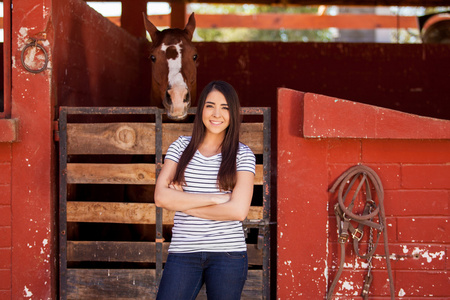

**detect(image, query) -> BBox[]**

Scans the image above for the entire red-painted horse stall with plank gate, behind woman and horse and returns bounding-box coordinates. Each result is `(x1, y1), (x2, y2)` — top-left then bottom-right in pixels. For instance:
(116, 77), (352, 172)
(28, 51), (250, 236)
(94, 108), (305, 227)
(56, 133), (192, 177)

(0, 0), (450, 299)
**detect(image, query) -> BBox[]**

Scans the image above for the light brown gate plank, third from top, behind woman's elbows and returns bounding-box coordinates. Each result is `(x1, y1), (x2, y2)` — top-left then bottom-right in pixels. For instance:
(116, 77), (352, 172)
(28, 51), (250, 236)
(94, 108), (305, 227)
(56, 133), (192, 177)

(67, 201), (263, 225)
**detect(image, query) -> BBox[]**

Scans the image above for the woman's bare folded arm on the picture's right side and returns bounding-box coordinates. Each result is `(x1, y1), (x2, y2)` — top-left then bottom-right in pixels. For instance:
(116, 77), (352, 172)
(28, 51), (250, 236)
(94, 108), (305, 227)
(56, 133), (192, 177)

(183, 171), (255, 221)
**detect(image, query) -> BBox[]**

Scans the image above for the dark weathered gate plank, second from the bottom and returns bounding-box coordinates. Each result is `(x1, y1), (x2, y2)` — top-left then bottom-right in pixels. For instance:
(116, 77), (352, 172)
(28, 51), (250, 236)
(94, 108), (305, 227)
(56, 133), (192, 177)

(67, 241), (262, 266)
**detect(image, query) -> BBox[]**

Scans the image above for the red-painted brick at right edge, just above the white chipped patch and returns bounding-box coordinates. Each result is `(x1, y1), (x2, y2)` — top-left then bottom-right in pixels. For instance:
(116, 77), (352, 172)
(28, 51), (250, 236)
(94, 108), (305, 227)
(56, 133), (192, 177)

(397, 217), (450, 243)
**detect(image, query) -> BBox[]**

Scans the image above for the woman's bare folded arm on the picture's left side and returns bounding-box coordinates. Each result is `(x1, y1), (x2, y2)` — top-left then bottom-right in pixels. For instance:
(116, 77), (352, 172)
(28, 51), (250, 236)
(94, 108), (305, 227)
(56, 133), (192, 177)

(155, 159), (230, 211)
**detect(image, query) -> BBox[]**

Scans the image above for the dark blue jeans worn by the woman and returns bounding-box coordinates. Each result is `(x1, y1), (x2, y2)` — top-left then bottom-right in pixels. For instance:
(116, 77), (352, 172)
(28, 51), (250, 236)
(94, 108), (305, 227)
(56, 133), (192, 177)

(156, 251), (248, 300)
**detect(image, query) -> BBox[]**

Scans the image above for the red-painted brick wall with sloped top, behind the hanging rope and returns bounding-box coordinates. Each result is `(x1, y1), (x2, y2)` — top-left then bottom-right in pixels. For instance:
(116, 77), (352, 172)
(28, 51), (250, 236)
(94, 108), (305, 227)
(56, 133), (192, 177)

(277, 89), (450, 299)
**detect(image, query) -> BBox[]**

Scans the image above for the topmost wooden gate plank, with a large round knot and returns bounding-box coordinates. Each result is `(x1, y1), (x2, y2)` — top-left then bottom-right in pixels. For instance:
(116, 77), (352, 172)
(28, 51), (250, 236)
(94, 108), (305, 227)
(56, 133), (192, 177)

(67, 123), (263, 155)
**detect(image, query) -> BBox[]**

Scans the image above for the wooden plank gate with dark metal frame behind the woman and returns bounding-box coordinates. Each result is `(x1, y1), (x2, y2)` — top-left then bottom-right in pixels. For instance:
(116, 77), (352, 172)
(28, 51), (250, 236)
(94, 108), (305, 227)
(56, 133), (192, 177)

(59, 107), (270, 299)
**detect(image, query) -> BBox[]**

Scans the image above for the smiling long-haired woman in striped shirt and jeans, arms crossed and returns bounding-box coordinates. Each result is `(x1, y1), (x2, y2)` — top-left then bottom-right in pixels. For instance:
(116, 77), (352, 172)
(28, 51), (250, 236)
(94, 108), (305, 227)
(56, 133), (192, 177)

(155, 81), (255, 300)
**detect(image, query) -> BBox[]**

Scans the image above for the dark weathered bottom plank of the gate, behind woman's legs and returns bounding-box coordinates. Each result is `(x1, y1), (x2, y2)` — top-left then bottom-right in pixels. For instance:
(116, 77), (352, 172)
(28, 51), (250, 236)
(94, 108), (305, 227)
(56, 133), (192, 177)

(67, 269), (263, 299)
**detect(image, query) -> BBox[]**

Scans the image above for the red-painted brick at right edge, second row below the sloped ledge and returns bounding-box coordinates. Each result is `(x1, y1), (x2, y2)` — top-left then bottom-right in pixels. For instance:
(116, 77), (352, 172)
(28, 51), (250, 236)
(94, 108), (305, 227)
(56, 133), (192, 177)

(402, 164), (450, 189)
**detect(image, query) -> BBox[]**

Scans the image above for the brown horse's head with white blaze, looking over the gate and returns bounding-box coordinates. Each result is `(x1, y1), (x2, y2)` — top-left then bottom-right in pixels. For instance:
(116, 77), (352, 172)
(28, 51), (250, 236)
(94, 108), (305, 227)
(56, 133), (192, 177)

(144, 13), (197, 120)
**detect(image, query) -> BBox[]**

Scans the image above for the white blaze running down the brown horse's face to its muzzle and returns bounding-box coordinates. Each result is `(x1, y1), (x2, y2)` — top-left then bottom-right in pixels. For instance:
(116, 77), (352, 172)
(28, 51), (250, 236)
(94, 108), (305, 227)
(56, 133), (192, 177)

(161, 42), (190, 120)
